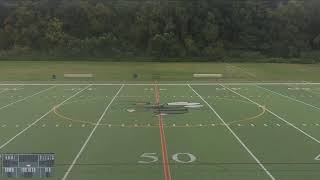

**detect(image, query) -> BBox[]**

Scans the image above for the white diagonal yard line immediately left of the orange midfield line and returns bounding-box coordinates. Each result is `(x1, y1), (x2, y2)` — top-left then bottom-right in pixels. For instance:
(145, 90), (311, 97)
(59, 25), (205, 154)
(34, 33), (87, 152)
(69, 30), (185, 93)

(62, 84), (124, 180)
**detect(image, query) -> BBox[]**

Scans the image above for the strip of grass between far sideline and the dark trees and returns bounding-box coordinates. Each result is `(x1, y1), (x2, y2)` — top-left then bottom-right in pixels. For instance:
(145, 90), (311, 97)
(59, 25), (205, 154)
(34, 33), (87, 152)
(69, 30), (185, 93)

(0, 61), (320, 81)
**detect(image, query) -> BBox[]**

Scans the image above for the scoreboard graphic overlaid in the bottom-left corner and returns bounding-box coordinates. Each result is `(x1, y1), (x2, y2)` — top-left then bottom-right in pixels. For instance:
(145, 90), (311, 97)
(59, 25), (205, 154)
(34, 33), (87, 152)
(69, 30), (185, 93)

(1, 153), (55, 178)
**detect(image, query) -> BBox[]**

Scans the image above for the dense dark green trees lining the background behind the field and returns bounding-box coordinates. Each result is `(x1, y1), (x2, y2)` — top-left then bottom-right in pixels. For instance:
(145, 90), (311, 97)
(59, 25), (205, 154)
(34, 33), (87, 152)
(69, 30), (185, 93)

(0, 0), (320, 61)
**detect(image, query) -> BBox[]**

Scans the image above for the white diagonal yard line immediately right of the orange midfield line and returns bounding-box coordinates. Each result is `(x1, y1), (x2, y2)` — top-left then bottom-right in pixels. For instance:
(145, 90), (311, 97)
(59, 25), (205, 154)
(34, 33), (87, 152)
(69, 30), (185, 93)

(188, 85), (275, 180)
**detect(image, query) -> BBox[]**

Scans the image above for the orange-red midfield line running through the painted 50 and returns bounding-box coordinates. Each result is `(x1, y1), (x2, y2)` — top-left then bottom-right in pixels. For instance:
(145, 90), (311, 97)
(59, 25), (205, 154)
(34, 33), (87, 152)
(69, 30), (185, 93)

(154, 83), (171, 180)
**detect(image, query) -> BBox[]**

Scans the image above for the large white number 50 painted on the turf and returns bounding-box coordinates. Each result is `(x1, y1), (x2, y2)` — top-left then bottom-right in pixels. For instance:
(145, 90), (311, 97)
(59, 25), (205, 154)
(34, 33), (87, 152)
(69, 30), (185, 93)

(138, 153), (197, 164)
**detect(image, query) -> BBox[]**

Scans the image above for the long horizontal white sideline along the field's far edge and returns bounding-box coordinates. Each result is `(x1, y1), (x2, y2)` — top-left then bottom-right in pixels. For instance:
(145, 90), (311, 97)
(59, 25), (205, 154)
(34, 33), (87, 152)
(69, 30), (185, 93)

(0, 82), (320, 86)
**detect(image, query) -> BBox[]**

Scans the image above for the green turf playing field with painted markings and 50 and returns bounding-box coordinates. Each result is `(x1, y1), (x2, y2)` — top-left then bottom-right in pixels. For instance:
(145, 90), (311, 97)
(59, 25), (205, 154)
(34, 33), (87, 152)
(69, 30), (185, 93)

(0, 83), (320, 180)
